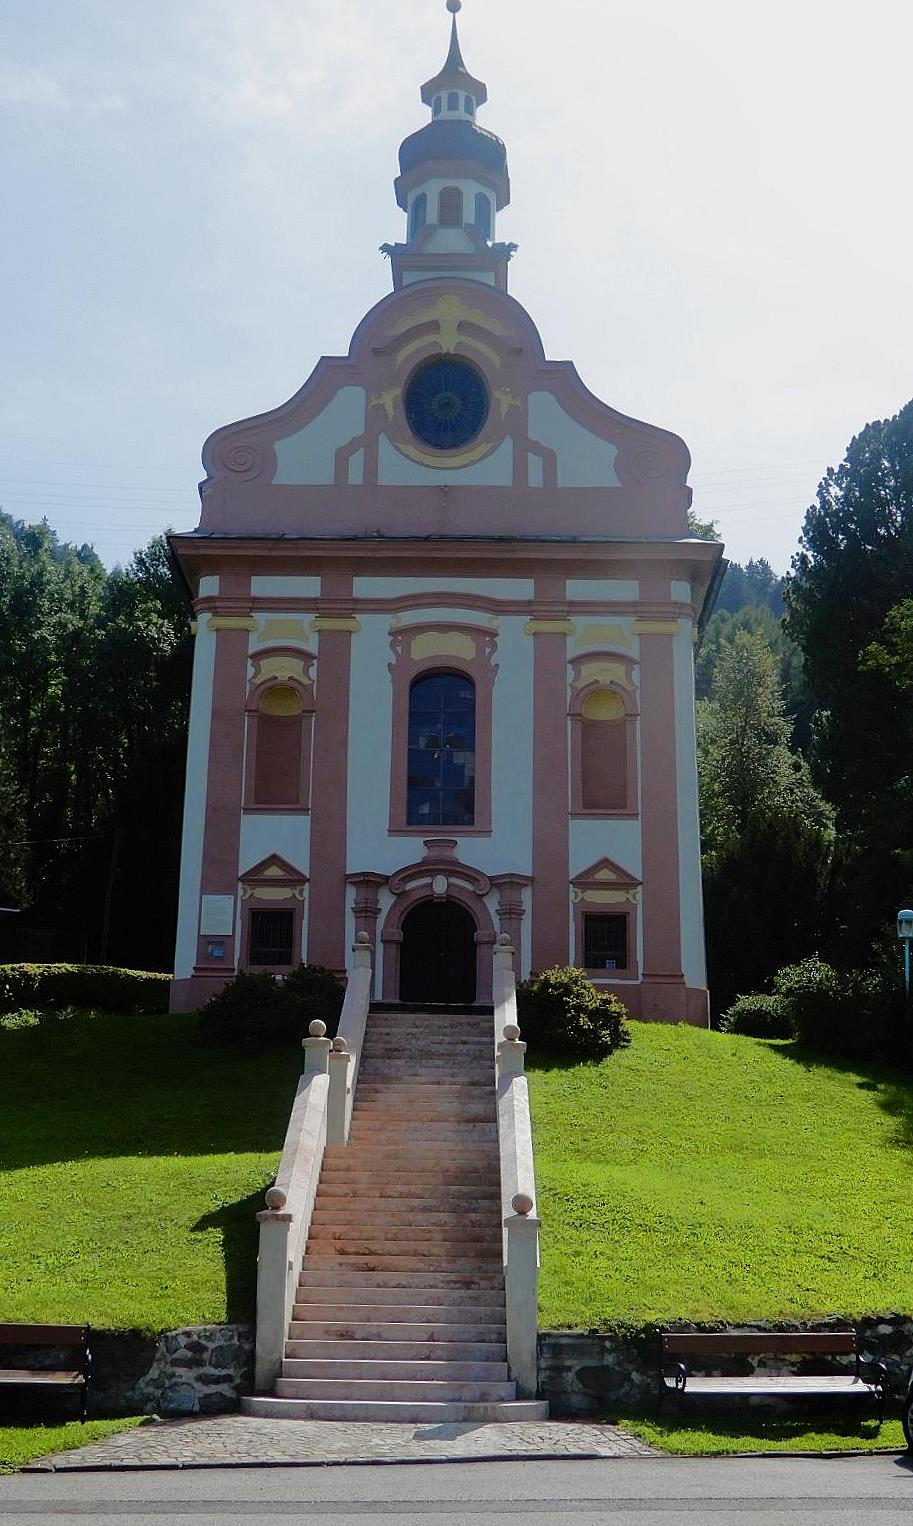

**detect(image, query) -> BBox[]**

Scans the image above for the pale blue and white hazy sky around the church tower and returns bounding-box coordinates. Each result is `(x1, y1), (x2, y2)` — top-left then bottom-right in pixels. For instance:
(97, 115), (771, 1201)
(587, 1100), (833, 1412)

(0, 0), (913, 571)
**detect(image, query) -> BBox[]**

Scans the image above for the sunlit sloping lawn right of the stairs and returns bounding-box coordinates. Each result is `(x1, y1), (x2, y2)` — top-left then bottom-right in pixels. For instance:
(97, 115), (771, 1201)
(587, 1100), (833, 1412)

(528, 1022), (913, 1329)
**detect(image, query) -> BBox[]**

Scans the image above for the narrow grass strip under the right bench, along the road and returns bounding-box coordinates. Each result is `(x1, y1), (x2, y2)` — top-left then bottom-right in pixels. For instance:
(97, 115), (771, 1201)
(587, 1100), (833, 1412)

(609, 1410), (907, 1457)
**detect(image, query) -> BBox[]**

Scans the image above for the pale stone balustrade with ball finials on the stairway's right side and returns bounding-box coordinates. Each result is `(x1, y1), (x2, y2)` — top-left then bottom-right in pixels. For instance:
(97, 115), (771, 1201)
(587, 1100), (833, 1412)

(492, 940), (540, 1398)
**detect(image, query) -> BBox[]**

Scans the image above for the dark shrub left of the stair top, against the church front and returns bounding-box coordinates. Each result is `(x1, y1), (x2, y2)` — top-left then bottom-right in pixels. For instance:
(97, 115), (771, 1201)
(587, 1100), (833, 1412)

(200, 964), (345, 1053)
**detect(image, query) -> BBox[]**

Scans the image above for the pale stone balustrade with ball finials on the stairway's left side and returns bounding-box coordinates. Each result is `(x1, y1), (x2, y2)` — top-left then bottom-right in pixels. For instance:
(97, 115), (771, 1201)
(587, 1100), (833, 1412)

(255, 934), (371, 1392)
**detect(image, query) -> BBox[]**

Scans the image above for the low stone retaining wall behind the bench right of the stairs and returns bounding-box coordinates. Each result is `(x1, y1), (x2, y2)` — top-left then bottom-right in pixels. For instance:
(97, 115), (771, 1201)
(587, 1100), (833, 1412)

(539, 1314), (913, 1416)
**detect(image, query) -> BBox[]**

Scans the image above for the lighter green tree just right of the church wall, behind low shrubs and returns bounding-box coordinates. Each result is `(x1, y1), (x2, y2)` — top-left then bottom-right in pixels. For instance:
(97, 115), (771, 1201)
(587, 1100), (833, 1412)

(698, 629), (834, 1012)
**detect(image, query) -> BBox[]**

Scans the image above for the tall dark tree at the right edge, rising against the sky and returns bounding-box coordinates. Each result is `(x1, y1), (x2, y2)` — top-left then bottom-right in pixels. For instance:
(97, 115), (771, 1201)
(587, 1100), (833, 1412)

(786, 401), (913, 961)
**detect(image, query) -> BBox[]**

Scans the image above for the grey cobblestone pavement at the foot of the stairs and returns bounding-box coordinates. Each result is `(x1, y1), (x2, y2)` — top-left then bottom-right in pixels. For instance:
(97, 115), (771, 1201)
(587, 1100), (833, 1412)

(26, 1415), (653, 1471)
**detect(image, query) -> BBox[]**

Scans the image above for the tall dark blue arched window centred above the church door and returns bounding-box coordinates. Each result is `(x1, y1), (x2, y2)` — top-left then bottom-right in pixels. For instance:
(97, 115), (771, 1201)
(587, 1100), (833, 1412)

(406, 673), (475, 827)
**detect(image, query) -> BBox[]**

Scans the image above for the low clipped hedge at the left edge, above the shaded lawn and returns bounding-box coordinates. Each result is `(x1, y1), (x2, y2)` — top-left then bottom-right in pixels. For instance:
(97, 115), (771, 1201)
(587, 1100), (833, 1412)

(0, 964), (171, 1013)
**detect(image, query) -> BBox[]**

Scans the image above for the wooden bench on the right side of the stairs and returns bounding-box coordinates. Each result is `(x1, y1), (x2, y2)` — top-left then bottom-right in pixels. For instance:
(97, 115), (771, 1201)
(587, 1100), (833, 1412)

(660, 1331), (887, 1421)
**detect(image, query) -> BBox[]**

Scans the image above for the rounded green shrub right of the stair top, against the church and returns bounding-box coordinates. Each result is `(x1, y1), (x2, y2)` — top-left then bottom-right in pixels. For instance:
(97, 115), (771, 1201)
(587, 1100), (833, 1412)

(518, 964), (631, 1059)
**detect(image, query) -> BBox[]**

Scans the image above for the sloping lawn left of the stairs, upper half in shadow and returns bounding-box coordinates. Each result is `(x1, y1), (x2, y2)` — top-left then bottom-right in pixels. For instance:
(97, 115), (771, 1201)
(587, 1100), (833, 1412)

(0, 1013), (301, 1334)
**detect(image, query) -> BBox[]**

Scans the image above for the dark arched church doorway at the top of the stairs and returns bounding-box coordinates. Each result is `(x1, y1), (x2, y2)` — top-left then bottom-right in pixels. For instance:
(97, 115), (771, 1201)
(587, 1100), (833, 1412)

(400, 900), (476, 1006)
